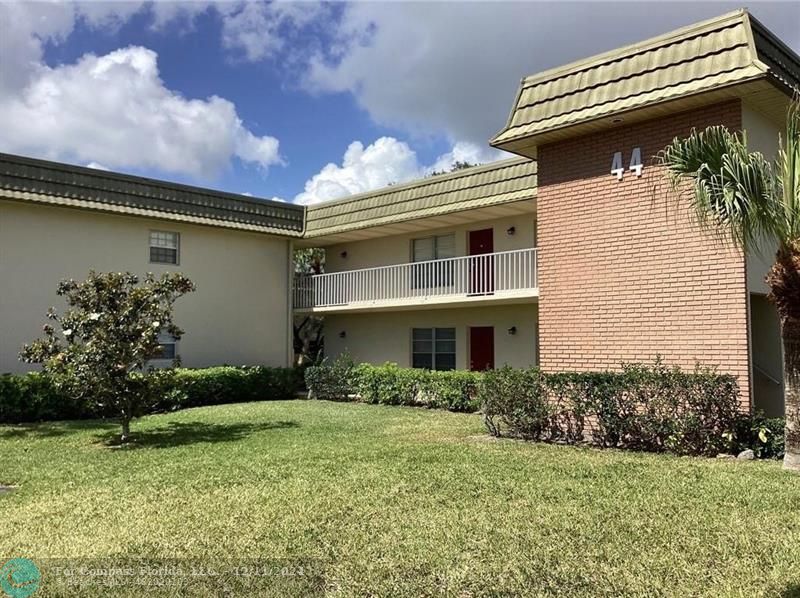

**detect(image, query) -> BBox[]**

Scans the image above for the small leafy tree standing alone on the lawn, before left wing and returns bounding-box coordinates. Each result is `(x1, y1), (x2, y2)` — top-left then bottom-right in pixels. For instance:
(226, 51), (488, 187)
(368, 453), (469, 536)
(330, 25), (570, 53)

(20, 271), (195, 443)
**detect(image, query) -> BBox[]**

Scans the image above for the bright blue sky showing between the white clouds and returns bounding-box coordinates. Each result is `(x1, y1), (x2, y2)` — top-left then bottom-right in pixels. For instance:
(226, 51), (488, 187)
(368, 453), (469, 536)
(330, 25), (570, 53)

(40, 4), (418, 197)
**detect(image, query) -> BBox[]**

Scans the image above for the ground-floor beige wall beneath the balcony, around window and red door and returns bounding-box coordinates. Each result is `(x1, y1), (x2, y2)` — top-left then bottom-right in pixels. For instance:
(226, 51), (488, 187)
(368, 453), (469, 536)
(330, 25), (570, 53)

(325, 303), (538, 369)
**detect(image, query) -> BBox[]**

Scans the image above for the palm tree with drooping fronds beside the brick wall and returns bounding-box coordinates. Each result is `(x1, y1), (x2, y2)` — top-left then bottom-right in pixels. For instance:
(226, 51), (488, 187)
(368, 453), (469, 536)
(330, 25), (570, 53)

(657, 95), (800, 471)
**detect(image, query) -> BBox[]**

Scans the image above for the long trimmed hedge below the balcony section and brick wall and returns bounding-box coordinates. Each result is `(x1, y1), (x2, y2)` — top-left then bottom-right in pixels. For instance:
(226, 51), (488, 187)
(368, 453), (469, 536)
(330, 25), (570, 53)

(305, 355), (783, 457)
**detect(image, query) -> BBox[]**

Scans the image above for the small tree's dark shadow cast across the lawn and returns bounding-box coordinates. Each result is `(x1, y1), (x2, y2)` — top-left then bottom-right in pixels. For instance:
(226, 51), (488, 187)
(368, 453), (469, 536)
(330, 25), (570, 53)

(97, 421), (300, 449)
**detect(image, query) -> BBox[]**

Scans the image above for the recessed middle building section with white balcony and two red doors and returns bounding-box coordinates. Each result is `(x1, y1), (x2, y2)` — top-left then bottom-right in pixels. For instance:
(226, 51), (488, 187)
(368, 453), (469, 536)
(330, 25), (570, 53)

(294, 158), (539, 370)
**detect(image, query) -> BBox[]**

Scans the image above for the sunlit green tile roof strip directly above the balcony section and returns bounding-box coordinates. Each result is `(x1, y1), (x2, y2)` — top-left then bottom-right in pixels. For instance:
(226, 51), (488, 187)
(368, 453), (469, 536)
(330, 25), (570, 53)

(305, 158), (536, 237)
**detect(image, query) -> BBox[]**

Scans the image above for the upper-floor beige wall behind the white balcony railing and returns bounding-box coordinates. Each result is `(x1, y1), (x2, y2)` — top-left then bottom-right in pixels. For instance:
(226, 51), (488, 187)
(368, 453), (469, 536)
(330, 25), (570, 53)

(325, 214), (535, 272)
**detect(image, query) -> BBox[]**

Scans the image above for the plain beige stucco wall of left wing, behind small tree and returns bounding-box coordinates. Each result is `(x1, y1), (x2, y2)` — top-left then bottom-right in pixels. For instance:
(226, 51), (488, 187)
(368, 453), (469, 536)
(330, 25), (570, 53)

(0, 201), (290, 372)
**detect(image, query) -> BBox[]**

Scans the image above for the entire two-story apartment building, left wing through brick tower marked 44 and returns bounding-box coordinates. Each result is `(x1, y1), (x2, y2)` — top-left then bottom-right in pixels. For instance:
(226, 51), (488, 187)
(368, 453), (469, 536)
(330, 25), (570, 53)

(0, 11), (800, 420)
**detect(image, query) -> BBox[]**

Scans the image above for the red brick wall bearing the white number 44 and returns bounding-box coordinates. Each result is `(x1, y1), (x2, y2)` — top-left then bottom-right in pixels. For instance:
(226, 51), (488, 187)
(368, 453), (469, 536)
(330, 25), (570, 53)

(538, 101), (749, 410)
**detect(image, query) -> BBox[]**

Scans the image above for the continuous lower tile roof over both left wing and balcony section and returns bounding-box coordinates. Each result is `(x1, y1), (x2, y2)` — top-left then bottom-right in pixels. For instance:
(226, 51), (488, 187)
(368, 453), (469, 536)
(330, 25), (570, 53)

(0, 153), (536, 237)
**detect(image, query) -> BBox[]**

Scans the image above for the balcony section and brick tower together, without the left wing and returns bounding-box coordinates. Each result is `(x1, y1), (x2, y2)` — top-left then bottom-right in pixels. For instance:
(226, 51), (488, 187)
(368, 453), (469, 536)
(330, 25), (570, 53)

(295, 11), (800, 413)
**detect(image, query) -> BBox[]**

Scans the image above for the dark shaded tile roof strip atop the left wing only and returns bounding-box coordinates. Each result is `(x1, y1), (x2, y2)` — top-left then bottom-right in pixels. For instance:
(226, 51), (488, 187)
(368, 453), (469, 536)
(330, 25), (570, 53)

(0, 154), (304, 237)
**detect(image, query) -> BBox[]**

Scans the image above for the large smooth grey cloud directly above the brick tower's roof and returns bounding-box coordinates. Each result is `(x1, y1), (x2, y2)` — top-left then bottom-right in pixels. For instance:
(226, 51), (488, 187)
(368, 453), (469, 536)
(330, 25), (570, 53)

(304, 2), (800, 146)
